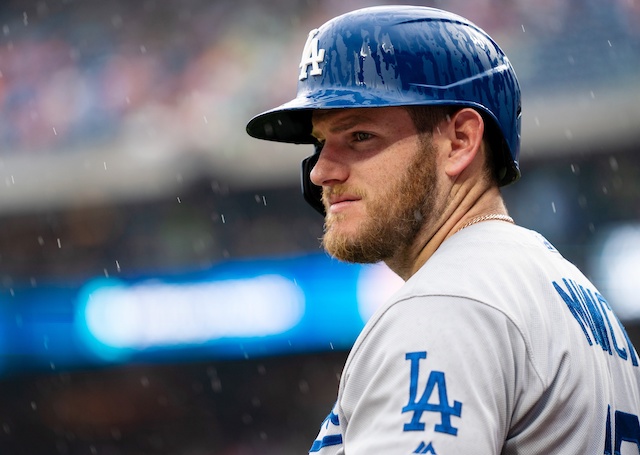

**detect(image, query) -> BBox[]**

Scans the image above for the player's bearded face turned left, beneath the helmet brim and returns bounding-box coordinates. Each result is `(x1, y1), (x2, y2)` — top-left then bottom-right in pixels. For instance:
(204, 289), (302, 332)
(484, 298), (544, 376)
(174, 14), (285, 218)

(311, 107), (437, 263)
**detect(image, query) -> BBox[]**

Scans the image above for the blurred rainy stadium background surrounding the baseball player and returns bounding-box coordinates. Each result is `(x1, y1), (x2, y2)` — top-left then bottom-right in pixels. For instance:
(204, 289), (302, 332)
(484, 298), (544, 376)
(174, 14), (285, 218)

(0, 0), (640, 455)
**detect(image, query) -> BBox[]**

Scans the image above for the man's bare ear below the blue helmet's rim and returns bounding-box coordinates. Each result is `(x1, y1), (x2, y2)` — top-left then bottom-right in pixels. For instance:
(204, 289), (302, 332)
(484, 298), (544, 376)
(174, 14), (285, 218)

(440, 108), (484, 178)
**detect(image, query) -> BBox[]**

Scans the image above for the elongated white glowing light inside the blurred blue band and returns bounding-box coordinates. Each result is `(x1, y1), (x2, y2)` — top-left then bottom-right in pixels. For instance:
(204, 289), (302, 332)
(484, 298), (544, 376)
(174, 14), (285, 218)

(80, 275), (304, 351)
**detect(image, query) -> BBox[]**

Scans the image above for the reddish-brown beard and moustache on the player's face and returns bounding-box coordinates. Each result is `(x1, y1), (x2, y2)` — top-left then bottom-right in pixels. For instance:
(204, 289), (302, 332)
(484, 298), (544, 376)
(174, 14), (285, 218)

(322, 139), (437, 264)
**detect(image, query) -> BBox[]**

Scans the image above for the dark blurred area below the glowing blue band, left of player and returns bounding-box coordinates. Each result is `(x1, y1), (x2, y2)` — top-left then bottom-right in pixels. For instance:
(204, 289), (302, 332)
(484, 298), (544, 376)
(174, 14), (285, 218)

(0, 352), (346, 455)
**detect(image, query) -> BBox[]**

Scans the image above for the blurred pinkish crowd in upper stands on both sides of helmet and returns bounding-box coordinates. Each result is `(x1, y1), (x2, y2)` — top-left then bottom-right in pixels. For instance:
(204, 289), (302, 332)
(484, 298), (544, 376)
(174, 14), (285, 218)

(0, 0), (640, 156)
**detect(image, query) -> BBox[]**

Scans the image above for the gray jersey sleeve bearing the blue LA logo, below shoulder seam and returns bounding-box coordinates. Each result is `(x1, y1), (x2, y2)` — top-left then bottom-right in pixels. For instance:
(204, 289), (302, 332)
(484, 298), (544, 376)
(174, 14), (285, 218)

(336, 296), (542, 455)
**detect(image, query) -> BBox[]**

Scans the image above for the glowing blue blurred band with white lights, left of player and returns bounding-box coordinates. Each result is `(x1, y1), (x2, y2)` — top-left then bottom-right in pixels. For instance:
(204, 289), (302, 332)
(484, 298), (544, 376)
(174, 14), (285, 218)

(0, 254), (402, 371)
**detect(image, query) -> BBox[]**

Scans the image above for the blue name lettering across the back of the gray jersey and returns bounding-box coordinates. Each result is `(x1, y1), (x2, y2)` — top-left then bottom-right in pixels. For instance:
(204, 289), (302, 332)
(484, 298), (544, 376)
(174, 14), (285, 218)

(553, 278), (638, 367)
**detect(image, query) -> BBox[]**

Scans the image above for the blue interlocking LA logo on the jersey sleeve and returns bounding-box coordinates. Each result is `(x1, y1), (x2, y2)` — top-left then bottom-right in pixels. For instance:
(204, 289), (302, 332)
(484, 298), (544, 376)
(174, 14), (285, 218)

(402, 351), (462, 436)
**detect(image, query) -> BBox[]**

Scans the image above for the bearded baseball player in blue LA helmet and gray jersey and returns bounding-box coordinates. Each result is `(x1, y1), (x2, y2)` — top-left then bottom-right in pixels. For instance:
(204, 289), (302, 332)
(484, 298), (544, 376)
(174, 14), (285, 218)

(247, 6), (640, 455)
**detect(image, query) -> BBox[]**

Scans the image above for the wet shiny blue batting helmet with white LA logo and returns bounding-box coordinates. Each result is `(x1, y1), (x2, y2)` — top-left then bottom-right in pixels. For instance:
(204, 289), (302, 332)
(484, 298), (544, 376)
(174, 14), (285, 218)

(247, 6), (521, 216)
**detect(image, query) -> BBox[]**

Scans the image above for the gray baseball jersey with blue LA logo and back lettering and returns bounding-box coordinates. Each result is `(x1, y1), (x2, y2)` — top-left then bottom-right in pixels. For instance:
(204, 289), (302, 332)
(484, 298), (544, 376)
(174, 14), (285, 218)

(309, 221), (640, 455)
